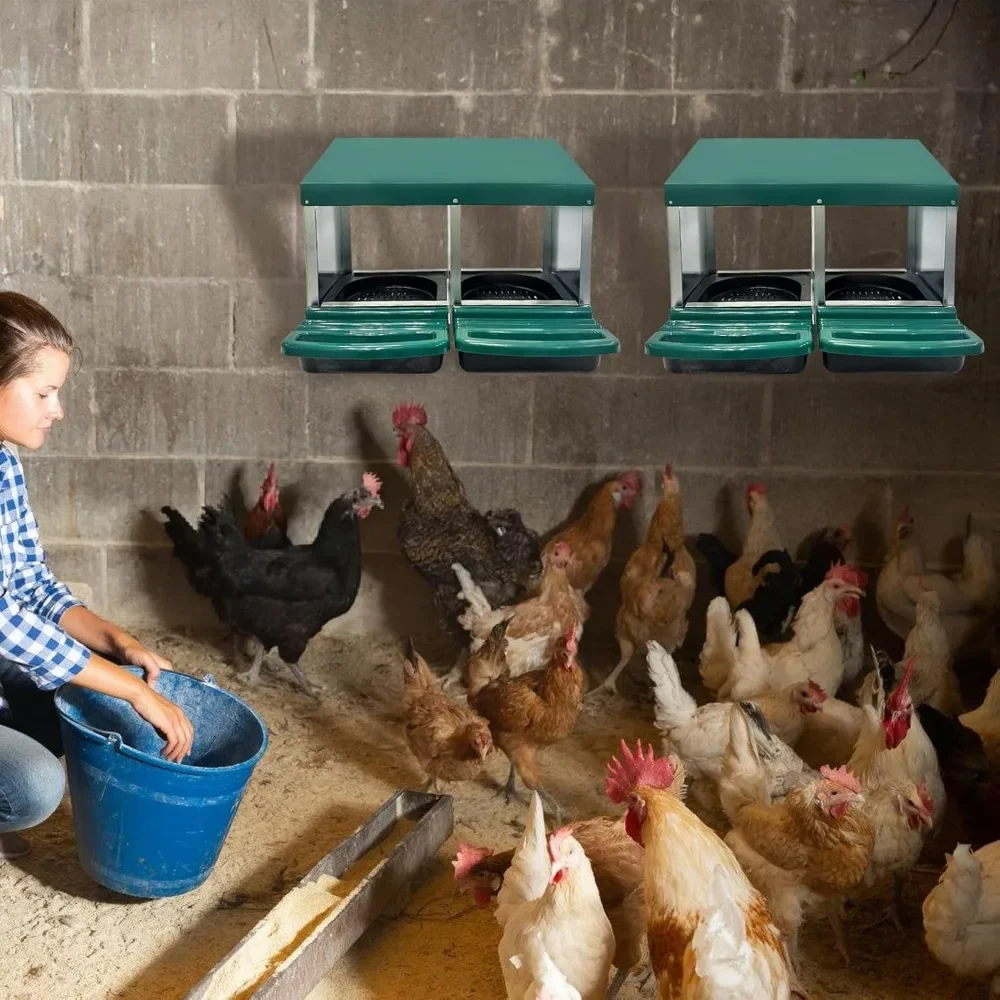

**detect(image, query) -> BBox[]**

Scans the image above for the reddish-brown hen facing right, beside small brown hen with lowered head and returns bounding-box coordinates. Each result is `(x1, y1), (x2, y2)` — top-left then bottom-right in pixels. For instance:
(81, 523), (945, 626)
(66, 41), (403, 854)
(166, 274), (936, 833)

(469, 629), (583, 816)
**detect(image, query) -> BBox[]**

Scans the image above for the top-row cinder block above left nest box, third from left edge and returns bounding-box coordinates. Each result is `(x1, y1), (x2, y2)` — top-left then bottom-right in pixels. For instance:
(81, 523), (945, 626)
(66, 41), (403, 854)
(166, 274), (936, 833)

(316, 0), (537, 91)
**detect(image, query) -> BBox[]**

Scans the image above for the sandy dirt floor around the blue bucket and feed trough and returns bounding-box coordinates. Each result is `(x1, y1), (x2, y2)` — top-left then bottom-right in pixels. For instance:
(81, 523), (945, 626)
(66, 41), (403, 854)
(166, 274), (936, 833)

(0, 633), (986, 1000)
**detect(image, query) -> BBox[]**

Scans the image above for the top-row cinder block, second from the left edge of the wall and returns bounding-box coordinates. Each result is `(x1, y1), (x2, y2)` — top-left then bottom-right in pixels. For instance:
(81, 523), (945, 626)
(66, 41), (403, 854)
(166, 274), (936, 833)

(90, 0), (308, 90)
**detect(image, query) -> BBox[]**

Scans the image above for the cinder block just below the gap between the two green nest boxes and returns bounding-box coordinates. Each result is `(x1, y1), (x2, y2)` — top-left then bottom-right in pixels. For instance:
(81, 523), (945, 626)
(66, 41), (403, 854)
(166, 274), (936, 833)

(533, 376), (764, 466)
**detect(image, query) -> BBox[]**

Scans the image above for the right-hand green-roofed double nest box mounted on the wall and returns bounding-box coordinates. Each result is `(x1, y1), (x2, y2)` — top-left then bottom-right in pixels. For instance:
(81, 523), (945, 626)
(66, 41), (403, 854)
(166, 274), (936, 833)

(646, 139), (983, 374)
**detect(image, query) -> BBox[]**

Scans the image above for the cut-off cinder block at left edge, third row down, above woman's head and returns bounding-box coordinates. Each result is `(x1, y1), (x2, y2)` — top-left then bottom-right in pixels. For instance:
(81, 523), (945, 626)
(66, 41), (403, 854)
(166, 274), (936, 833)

(0, 186), (87, 277)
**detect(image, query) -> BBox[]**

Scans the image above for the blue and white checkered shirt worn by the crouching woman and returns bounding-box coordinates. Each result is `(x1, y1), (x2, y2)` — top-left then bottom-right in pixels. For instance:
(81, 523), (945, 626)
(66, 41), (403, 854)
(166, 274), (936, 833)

(0, 445), (90, 715)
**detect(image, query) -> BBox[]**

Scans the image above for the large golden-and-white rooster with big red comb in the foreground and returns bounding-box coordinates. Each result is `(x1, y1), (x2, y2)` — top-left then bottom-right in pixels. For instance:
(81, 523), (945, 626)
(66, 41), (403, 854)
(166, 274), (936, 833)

(605, 740), (791, 1000)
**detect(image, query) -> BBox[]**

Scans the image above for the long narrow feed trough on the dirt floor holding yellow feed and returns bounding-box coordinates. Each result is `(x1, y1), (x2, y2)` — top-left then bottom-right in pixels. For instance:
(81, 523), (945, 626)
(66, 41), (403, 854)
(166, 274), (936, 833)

(185, 791), (454, 1000)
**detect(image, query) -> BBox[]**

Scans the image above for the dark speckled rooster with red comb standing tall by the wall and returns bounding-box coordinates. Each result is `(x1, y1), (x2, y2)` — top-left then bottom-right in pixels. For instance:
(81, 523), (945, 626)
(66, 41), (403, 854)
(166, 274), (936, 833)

(392, 404), (541, 645)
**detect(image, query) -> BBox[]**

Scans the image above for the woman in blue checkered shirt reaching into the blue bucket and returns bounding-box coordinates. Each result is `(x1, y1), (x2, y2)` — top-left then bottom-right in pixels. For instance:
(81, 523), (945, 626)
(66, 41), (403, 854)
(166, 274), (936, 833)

(0, 292), (194, 859)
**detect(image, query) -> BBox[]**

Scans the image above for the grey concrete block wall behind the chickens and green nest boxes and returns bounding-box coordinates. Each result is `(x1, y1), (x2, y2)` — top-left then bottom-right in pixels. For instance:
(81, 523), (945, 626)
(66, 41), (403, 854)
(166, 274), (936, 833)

(0, 0), (1000, 648)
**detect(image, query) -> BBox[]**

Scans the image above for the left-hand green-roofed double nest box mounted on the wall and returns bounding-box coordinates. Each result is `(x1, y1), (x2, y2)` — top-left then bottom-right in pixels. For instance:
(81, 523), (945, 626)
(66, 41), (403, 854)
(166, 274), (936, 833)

(282, 138), (619, 373)
